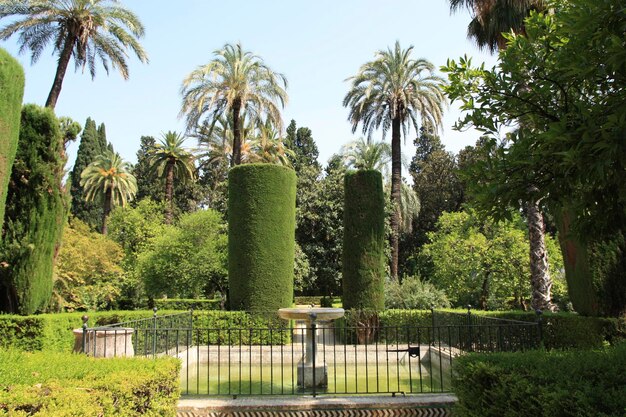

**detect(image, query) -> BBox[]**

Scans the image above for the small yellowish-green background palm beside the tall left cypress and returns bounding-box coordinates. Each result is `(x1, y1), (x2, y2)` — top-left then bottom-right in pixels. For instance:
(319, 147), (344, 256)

(80, 150), (137, 235)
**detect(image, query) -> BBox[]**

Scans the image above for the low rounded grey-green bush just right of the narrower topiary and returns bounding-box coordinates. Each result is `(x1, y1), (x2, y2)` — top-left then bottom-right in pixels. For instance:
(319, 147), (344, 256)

(385, 276), (450, 310)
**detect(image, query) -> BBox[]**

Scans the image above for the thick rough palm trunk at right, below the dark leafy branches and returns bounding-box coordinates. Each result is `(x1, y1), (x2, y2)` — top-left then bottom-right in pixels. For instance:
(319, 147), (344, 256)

(526, 200), (555, 311)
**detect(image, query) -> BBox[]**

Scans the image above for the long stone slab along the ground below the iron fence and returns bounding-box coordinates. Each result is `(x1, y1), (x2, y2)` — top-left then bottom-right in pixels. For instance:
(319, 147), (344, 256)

(177, 394), (456, 417)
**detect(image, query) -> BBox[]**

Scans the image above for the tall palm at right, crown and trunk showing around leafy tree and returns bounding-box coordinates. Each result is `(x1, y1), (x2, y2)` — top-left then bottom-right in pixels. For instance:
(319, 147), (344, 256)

(449, 0), (555, 310)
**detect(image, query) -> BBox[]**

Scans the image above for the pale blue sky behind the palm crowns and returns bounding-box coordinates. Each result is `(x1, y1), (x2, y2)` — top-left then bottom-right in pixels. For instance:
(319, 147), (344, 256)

(0, 0), (495, 169)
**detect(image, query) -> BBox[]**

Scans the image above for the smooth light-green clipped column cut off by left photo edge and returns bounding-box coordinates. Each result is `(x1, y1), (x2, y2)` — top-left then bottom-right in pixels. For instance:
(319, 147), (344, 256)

(0, 49), (24, 230)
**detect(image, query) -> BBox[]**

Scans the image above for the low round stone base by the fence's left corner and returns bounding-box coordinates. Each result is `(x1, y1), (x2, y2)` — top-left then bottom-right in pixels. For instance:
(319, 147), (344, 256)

(74, 327), (135, 358)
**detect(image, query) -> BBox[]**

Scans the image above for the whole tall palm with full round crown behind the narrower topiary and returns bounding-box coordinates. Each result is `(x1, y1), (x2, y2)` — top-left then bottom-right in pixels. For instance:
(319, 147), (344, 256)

(343, 42), (446, 280)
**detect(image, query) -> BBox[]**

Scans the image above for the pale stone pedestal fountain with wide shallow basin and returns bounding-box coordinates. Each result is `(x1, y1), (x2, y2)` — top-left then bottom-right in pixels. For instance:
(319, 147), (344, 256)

(278, 307), (345, 388)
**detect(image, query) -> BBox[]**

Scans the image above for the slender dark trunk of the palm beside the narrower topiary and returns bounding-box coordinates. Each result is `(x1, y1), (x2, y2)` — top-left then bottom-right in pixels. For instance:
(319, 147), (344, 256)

(391, 117), (402, 281)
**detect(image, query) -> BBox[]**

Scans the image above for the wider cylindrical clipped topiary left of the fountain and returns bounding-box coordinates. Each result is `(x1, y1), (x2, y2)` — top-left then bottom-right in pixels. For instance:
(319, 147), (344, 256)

(228, 164), (296, 311)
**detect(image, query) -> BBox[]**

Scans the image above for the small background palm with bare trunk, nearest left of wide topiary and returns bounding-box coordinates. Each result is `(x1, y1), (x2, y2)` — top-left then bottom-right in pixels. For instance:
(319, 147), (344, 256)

(149, 131), (196, 224)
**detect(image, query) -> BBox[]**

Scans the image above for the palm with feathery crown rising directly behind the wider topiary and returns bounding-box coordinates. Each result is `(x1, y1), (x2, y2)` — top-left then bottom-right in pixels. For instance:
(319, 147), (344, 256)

(180, 43), (287, 166)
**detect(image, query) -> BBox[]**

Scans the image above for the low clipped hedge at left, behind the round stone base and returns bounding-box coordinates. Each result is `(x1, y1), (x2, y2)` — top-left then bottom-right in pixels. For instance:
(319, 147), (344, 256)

(0, 310), (178, 352)
